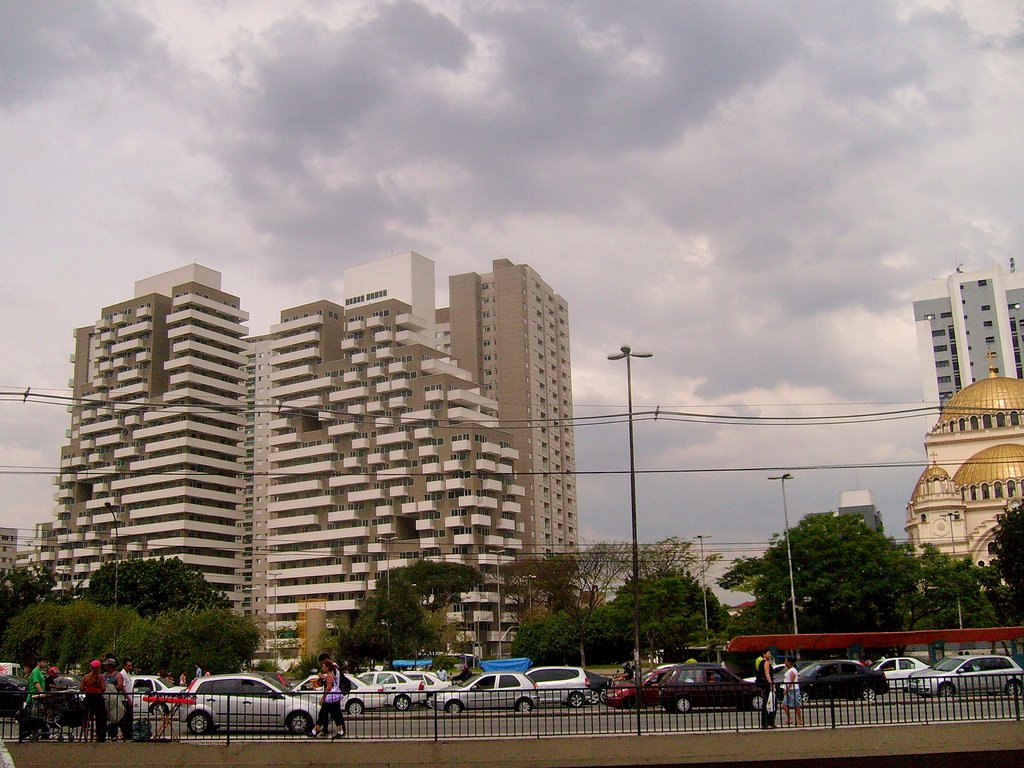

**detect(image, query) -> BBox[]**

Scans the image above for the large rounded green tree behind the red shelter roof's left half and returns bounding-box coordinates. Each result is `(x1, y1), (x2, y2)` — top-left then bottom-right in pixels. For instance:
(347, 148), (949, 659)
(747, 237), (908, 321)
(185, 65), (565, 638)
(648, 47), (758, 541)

(719, 515), (915, 632)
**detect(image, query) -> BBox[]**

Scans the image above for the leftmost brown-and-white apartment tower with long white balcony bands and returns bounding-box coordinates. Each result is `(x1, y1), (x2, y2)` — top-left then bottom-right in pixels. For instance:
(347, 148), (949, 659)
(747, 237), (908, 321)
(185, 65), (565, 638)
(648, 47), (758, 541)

(52, 264), (248, 603)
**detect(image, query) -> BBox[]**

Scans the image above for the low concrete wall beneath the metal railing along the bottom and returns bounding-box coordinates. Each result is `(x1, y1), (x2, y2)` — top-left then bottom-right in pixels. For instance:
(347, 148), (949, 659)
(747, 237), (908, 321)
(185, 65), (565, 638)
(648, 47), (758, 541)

(7, 722), (1024, 768)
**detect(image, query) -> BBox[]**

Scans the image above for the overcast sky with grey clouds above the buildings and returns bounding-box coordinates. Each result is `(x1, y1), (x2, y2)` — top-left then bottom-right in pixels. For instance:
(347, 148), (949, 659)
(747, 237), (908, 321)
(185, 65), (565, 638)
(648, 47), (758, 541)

(0, 0), (1024, 589)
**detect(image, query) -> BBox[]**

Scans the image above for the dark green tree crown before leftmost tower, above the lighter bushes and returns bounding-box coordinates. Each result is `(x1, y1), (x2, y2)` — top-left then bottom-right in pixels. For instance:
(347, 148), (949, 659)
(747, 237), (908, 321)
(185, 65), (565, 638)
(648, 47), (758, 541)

(84, 557), (228, 617)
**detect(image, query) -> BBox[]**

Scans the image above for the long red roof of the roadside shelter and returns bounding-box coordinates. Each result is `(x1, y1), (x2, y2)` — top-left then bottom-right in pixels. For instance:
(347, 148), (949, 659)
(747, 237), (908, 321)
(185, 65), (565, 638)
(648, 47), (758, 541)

(725, 627), (1024, 652)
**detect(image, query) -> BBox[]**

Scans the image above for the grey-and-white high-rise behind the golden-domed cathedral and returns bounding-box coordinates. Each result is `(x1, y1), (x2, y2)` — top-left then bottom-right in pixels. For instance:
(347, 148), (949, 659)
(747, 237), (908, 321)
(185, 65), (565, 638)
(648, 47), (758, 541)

(912, 263), (1024, 403)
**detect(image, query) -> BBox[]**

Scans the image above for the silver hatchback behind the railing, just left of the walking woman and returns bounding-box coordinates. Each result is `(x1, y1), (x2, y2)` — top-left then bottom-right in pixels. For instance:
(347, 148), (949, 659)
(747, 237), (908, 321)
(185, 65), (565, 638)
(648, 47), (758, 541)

(178, 674), (316, 735)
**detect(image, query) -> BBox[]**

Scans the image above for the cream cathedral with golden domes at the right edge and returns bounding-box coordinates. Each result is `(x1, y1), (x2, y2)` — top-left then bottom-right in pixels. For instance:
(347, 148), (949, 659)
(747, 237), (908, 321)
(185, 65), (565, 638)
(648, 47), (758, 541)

(906, 368), (1024, 565)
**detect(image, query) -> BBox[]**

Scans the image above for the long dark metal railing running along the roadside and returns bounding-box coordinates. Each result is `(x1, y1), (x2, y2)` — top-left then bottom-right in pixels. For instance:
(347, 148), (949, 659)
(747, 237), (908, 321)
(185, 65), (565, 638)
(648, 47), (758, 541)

(0, 676), (1024, 742)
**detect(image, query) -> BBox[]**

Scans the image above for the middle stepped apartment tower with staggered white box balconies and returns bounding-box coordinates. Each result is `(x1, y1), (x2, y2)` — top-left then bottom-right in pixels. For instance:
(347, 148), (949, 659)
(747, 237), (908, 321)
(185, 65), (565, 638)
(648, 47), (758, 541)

(265, 259), (525, 652)
